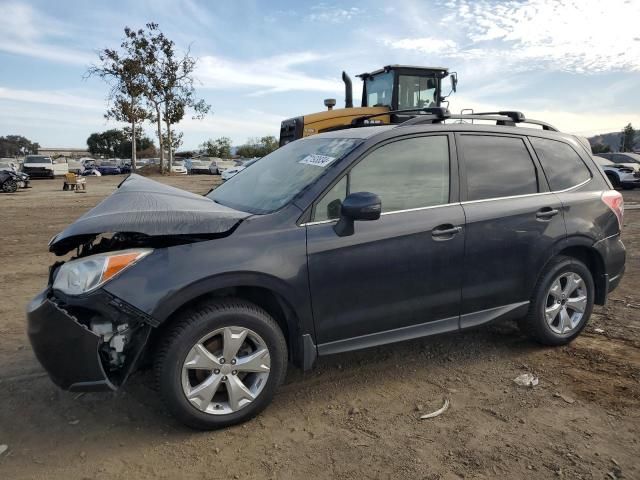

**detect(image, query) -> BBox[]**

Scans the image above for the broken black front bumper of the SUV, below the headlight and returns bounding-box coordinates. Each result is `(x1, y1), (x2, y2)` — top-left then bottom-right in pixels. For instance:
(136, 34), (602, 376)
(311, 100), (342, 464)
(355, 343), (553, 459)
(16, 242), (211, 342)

(27, 288), (153, 391)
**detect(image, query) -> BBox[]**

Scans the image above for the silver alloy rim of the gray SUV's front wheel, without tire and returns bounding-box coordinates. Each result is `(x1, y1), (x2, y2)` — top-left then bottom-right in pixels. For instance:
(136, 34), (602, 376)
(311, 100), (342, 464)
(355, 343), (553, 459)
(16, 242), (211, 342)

(182, 326), (271, 415)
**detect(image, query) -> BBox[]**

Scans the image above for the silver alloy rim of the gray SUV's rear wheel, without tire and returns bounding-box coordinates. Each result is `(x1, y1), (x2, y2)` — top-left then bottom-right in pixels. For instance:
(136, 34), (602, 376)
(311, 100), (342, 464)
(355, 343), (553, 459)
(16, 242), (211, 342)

(544, 272), (588, 335)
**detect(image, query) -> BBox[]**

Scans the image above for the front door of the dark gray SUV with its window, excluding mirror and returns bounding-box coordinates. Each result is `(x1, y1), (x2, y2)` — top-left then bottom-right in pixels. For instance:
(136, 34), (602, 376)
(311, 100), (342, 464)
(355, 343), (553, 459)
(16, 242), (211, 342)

(306, 134), (464, 354)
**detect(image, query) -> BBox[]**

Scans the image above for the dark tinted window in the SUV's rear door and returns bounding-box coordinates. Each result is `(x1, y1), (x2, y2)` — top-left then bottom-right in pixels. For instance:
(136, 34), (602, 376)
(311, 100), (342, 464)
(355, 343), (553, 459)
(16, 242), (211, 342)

(460, 135), (538, 200)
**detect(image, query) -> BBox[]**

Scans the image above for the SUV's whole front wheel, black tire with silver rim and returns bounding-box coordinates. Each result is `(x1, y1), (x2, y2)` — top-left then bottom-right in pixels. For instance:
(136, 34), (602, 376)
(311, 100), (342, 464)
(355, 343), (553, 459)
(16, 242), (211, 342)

(155, 299), (287, 430)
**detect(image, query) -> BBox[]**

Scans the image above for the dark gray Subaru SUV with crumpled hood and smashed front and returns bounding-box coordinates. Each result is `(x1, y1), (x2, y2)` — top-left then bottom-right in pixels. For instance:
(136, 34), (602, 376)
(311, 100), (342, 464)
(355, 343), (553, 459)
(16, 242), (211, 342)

(28, 111), (625, 429)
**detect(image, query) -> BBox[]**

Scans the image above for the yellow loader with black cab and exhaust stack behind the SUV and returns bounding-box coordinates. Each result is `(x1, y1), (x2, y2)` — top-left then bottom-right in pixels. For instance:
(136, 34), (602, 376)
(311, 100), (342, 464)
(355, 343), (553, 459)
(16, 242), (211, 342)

(280, 65), (458, 146)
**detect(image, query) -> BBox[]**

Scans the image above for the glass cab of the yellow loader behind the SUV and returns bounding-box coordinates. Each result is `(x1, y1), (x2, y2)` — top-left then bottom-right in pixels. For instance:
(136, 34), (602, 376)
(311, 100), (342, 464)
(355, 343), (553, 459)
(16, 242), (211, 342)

(358, 65), (456, 110)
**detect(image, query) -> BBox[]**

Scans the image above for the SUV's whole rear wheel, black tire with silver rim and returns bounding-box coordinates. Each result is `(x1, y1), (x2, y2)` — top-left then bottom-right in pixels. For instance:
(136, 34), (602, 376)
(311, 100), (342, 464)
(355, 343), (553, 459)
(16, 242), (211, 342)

(520, 256), (595, 346)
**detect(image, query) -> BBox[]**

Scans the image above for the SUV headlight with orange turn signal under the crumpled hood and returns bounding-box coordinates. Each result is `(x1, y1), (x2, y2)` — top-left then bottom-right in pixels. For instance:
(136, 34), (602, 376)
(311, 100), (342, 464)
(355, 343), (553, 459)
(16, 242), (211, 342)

(53, 248), (153, 295)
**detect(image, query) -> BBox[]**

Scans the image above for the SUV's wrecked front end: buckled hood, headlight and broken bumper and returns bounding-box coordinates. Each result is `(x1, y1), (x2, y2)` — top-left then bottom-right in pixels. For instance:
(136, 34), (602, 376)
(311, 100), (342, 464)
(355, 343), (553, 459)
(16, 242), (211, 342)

(27, 175), (249, 390)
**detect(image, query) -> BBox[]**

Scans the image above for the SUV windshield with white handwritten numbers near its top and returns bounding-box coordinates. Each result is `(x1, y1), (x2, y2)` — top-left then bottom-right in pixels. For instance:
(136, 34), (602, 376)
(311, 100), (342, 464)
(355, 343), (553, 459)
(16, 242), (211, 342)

(207, 137), (362, 214)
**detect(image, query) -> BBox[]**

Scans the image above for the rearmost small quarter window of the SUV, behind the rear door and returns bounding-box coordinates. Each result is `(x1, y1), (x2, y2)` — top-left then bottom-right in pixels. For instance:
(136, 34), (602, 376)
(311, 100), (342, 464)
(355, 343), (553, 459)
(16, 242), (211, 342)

(529, 138), (591, 190)
